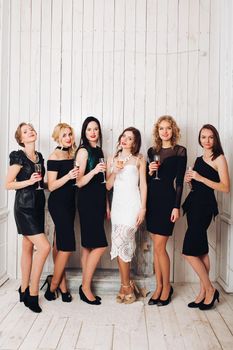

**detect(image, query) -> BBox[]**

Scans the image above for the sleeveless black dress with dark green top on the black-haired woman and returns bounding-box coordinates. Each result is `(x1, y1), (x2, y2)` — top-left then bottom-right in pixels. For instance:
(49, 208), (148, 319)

(78, 146), (108, 248)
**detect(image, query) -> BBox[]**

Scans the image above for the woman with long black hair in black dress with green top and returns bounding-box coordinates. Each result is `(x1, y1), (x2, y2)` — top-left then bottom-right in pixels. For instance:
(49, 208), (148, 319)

(76, 117), (108, 305)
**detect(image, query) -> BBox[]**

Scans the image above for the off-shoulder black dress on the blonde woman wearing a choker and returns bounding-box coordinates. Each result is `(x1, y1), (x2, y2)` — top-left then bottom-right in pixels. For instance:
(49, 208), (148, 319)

(47, 159), (76, 252)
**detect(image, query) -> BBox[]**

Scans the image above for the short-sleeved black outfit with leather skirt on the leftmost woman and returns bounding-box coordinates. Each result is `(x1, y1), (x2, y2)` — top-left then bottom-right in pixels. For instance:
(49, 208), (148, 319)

(10, 150), (45, 236)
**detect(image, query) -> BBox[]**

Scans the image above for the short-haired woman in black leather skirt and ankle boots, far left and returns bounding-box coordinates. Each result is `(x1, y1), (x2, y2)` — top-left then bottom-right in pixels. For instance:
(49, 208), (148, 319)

(6, 123), (50, 313)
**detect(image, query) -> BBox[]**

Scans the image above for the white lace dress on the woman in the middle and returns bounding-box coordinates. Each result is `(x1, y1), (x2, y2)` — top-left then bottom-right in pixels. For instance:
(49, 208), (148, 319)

(111, 163), (141, 262)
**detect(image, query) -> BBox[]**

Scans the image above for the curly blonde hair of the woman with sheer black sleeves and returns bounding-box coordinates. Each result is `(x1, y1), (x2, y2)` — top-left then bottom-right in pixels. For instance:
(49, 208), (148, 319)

(153, 115), (180, 152)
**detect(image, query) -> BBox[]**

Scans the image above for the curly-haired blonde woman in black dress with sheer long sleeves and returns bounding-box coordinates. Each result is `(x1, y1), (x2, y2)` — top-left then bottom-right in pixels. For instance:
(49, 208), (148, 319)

(146, 116), (187, 306)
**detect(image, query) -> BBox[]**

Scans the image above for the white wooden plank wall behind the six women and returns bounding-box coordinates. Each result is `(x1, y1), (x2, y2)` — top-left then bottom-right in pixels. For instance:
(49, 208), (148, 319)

(0, 0), (231, 281)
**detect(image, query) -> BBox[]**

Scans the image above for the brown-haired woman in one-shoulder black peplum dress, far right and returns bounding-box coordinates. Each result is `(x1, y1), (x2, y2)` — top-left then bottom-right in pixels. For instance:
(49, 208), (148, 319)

(182, 124), (230, 310)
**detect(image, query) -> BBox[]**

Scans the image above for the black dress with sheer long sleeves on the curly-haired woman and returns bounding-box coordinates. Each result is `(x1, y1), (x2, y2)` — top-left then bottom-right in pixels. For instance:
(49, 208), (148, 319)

(146, 145), (187, 236)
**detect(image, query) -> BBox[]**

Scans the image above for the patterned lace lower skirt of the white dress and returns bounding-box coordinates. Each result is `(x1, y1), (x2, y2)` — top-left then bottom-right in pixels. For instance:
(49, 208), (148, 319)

(111, 224), (137, 262)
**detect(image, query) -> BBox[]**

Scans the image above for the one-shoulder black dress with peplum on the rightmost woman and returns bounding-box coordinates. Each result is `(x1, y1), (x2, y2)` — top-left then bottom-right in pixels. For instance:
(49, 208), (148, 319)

(182, 157), (220, 256)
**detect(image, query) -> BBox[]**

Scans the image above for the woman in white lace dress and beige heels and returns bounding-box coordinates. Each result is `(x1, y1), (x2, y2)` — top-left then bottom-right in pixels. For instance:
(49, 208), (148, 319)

(106, 127), (147, 304)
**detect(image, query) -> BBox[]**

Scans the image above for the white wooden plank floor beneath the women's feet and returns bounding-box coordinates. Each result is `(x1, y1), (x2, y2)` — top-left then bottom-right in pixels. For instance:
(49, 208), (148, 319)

(0, 280), (233, 350)
